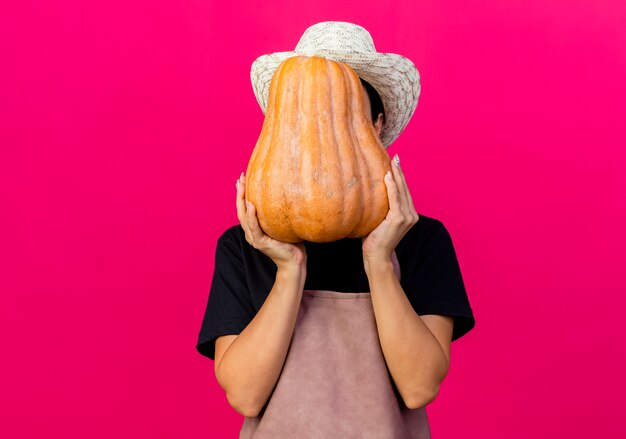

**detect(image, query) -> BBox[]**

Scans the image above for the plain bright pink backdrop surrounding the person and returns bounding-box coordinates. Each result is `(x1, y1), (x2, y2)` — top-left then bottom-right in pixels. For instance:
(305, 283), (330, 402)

(0, 0), (626, 439)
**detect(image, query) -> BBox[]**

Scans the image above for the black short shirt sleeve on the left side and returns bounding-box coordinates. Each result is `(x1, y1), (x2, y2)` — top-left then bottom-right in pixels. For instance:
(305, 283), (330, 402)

(196, 230), (254, 360)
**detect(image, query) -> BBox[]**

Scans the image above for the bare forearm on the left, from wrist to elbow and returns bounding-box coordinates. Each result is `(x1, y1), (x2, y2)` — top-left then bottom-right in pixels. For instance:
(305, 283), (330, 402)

(216, 266), (306, 416)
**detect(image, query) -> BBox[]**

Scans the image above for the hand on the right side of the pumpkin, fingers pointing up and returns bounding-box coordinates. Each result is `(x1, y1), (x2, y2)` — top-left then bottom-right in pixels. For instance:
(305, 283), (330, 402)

(362, 154), (419, 264)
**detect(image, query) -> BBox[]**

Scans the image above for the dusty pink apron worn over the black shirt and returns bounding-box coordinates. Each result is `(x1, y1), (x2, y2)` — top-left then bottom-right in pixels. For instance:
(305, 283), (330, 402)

(239, 253), (431, 439)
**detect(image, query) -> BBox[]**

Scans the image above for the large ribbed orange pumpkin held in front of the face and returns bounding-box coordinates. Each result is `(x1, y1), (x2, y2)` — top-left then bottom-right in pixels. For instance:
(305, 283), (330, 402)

(245, 56), (390, 243)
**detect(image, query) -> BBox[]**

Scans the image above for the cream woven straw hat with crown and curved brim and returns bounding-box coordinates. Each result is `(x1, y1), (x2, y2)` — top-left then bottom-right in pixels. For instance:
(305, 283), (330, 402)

(250, 21), (421, 148)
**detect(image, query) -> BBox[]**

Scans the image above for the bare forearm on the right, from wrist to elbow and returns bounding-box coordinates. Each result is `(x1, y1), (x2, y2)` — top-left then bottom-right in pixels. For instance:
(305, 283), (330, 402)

(366, 260), (447, 408)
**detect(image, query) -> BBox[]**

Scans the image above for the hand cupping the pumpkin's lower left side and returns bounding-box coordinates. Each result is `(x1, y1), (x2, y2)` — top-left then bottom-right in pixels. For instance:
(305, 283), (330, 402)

(236, 172), (306, 268)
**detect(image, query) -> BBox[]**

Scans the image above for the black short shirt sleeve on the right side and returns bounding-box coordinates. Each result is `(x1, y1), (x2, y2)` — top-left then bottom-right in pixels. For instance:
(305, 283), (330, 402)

(402, 220), (476, 341)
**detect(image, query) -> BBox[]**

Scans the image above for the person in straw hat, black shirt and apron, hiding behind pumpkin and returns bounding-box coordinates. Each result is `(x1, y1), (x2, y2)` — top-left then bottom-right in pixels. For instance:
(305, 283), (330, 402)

(197, 22), (475, 438)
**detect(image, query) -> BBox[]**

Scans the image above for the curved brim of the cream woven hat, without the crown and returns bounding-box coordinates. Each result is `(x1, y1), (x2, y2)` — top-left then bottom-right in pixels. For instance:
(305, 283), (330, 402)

(250, 49), (421, 148)
